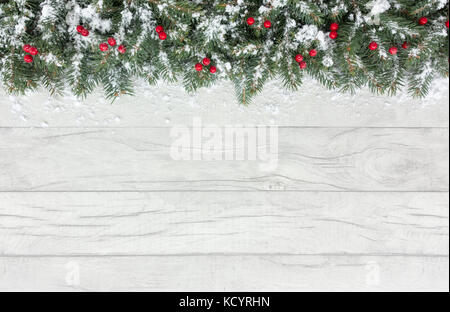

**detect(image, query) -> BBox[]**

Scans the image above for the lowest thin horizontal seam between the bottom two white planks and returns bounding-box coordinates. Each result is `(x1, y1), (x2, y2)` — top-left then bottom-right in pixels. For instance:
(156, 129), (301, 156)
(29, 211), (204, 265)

(0, 253), (449, 259)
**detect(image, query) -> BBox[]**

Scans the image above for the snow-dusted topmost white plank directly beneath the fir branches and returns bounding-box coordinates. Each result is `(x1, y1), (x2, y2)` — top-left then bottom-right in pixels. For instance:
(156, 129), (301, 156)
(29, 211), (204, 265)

(0, 79), (449, 127)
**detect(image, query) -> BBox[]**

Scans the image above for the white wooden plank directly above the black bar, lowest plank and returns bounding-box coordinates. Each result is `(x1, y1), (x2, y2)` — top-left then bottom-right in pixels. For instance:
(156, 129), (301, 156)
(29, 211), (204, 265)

(0, 256), (449, 292)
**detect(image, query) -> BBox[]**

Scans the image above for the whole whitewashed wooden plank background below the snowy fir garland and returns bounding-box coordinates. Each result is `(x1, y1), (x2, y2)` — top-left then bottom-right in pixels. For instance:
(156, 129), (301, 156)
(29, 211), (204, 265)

(0, 80), (449, 291)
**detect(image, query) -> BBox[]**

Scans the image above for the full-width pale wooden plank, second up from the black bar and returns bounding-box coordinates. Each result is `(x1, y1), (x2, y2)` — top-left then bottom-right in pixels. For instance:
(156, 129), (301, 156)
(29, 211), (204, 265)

(0, 192), (449, 256)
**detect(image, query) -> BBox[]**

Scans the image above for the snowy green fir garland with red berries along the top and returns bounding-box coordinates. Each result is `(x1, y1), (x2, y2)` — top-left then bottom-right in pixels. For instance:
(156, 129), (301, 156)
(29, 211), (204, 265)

(0, 0), (449, 104)
